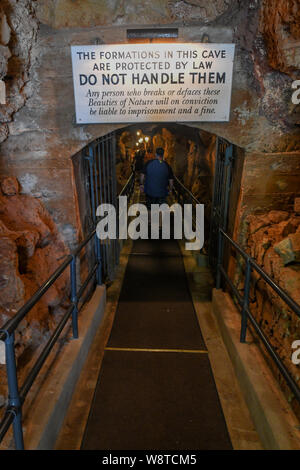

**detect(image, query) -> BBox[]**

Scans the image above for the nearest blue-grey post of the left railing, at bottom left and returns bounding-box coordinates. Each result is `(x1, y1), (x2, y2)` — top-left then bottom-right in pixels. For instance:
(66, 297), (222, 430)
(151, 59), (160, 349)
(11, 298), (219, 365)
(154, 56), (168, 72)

(5, 333), (24, 450)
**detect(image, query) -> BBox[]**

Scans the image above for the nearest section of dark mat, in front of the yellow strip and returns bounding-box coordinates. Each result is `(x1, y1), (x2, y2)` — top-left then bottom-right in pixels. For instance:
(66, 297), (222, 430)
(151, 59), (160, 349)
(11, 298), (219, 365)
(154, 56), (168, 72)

(82, 351), (231, 450)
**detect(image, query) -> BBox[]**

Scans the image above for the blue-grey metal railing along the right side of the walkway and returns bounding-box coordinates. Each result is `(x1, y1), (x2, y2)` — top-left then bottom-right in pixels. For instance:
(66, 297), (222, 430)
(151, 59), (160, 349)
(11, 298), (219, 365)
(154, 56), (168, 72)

(175, 178), (300, 402)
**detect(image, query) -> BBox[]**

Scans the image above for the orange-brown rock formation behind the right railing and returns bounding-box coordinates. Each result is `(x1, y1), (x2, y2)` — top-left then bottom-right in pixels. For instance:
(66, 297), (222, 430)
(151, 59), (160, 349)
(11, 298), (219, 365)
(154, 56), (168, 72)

(240, 205), (300, 412)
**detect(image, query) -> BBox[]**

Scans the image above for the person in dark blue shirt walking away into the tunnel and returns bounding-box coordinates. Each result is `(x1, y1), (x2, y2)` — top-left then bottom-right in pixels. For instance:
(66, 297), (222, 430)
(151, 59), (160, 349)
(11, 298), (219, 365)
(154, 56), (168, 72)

(140, 147), (174, 209)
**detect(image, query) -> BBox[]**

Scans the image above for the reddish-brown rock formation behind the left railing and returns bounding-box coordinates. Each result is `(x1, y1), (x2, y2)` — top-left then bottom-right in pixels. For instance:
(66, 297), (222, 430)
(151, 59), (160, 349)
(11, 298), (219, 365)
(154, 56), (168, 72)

(0, 177), (68, 402)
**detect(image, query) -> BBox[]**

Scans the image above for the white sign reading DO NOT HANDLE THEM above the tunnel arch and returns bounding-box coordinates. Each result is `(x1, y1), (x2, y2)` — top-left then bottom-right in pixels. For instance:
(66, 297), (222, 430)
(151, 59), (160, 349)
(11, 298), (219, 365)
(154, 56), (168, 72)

(71, 43), (234, 124)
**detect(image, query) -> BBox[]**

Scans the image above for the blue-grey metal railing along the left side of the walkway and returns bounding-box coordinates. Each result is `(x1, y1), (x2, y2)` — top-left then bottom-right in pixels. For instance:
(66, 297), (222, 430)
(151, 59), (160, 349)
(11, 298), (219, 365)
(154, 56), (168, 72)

(0, 173), (134, 450)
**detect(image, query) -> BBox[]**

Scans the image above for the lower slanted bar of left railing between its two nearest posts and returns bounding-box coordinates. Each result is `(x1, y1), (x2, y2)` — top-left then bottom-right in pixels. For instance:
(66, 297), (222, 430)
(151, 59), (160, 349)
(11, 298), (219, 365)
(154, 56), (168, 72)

(20, 305), (74, 402)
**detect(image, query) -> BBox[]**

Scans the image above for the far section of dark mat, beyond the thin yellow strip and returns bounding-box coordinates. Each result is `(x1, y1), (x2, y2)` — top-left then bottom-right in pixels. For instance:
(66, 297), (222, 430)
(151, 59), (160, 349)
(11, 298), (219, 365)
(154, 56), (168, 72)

(108, 240), (205, 349)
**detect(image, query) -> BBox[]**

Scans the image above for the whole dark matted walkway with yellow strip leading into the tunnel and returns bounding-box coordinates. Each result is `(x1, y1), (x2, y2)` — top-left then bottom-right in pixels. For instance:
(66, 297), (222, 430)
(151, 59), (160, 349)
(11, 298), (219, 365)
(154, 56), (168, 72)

(81, 233), (232, 450)
